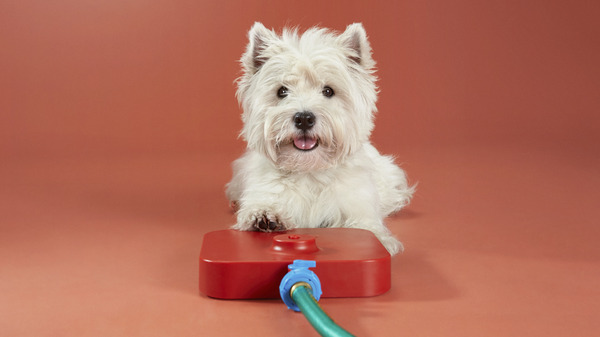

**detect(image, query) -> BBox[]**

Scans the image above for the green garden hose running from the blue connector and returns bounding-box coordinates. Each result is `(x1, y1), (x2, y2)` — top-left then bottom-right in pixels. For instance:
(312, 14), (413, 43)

(290, 282), (354, 337)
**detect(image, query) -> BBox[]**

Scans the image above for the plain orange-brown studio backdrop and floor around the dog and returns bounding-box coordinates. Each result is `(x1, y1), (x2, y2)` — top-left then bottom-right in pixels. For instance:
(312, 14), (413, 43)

(0, 0), (600, 336)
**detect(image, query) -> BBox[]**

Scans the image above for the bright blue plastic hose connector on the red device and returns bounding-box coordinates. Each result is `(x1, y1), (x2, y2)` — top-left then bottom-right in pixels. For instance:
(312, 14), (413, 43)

(279, 260), (323, 311)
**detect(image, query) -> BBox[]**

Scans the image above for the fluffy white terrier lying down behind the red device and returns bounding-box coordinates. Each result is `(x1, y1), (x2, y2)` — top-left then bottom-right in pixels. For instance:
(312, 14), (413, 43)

(227, 23), (413, 255)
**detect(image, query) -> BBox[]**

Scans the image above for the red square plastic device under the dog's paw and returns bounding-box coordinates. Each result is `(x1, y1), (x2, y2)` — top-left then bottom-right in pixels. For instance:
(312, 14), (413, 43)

(200, 228), (391, 299)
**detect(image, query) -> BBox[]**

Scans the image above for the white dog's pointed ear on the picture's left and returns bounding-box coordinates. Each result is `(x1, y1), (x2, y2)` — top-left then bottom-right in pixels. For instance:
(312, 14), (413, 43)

(241, 22), (278, 74)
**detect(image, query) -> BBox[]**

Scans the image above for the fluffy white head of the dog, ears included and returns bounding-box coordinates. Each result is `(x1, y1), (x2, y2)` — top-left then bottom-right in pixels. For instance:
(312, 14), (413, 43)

(237, 23), (377, 171)
